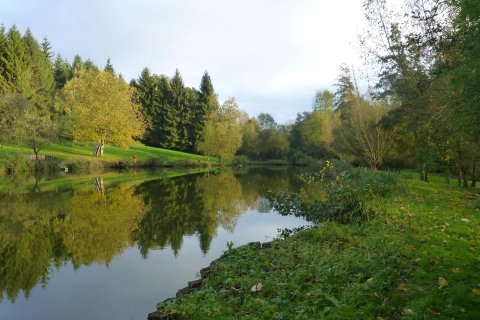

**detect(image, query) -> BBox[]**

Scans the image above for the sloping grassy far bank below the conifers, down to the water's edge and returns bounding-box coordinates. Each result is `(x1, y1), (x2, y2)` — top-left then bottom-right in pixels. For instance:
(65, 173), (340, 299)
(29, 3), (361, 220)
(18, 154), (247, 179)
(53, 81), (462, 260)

(0, 143), (215, 169)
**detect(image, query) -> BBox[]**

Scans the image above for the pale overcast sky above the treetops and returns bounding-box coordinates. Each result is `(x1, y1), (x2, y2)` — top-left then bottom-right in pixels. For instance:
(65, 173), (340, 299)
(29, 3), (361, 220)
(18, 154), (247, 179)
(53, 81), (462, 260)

(0, 0), (363, 123)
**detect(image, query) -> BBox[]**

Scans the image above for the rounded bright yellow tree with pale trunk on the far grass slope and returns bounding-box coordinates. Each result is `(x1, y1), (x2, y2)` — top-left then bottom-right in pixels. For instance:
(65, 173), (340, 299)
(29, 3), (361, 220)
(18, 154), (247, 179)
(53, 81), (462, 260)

(60, 71), (144, 156)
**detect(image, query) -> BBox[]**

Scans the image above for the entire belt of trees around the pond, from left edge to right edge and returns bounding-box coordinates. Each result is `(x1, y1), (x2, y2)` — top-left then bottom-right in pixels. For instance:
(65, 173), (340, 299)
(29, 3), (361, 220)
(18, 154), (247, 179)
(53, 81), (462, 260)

(0, 0), (480, 186)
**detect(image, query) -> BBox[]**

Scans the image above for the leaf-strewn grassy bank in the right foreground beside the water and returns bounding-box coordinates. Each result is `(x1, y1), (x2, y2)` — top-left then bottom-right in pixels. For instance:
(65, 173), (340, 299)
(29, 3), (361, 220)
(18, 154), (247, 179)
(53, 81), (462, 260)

(160, 174), (480, 320)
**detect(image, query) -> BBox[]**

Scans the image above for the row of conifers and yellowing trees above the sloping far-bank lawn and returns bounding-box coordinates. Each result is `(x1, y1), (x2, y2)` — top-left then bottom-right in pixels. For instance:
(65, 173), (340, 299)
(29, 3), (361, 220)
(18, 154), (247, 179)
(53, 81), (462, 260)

(0, 26), (242, 159)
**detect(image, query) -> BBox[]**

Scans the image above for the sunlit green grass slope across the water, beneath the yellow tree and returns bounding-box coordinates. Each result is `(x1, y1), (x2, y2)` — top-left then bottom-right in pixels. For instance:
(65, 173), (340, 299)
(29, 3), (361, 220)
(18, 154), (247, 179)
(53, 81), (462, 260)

(0, 142), (212, 164)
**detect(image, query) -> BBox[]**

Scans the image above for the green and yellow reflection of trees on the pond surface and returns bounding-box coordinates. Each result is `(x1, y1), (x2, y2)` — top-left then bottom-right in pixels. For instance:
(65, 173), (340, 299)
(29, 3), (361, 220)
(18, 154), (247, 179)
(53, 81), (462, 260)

(0, 170), (298, 302)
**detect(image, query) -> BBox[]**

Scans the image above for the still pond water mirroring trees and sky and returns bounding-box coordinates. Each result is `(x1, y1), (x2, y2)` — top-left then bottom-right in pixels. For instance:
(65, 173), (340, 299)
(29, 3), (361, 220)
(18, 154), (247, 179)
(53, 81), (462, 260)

(0, 168), (307, 320)
